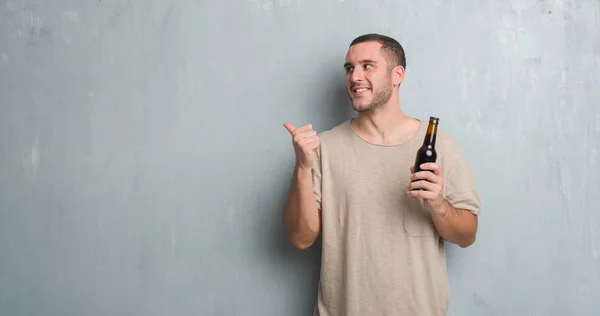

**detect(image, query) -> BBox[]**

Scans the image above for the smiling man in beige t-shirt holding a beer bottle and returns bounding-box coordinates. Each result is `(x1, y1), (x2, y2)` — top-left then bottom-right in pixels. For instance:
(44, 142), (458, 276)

(284, 34), (480, 316)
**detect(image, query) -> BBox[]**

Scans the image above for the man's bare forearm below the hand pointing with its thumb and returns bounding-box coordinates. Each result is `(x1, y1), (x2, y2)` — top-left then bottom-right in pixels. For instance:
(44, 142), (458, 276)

(284, 167), (321, 249)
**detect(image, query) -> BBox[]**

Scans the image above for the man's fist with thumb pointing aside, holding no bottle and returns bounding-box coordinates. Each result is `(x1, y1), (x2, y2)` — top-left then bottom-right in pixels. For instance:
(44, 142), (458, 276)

(283, 123), (321, 169)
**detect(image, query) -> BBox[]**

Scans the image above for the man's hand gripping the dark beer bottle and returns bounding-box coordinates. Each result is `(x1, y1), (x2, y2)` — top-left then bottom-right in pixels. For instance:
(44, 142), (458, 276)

(408, 162), (444, 213)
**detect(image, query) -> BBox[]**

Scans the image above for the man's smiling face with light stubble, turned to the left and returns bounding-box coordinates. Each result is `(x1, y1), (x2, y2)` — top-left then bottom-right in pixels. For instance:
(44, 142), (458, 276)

(344, 42), (394, 112)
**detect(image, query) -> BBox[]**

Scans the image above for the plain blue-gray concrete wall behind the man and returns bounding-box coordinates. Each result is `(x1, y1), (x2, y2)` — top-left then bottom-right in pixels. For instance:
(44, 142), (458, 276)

(0, 0), (600, 316)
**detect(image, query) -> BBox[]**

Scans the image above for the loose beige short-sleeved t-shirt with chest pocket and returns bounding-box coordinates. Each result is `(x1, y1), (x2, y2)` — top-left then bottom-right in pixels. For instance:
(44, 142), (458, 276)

(313, 120), (480, 316)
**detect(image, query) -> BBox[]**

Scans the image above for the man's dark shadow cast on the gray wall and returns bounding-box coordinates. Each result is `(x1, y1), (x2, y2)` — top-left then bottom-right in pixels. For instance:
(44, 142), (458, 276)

(261, 67), (352, 315)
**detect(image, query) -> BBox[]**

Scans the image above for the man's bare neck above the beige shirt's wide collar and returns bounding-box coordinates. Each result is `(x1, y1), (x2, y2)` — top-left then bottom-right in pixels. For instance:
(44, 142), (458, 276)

(351, 104), (420, 145)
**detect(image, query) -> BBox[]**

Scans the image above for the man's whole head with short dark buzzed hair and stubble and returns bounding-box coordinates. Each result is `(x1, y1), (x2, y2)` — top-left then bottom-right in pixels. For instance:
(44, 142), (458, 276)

(344, 34), (406, 112)
